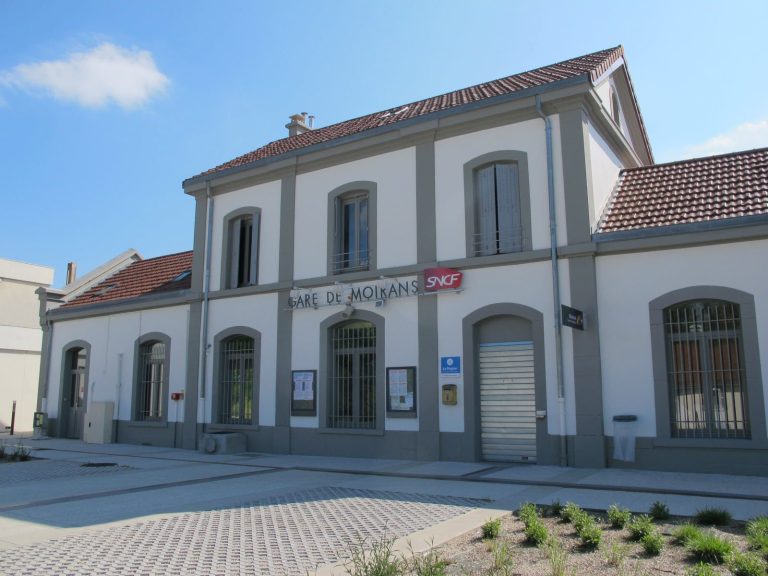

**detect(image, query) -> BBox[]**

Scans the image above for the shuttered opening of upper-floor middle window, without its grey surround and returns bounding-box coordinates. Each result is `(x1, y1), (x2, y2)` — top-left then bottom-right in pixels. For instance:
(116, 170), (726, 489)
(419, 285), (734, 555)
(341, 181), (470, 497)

(331, 193), (370, 273)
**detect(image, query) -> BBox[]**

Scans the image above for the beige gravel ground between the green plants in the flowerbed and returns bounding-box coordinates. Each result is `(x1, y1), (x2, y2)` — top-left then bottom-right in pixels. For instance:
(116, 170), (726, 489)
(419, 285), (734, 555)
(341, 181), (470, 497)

(437, 515), (746, 576)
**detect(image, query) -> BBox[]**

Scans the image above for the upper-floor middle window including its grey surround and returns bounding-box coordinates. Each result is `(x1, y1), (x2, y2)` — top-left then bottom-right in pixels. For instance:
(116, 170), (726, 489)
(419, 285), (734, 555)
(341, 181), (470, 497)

(328, 182), (376, 274)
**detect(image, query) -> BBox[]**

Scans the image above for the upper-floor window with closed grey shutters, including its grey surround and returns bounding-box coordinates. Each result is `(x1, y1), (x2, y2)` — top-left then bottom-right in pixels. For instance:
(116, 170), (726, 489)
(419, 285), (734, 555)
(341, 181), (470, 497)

(464, 150), (531, 256)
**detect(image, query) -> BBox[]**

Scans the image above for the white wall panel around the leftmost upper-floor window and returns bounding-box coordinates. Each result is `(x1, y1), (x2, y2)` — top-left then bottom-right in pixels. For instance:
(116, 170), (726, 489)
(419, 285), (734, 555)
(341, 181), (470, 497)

(211, 180), (281, 290)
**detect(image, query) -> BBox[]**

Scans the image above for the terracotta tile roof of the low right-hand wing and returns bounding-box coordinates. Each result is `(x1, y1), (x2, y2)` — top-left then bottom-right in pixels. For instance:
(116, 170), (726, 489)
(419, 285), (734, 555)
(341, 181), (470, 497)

(598, 148), (768, 233)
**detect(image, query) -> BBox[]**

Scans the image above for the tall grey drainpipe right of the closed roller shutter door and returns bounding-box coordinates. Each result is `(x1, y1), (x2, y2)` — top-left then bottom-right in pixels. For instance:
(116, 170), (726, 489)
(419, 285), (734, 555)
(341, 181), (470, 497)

(536, 95), (568, 466)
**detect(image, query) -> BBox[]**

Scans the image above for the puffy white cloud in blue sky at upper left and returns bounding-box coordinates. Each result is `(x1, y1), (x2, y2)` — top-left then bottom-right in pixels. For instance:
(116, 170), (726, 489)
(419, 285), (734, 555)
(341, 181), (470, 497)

(0, 42), (170, 108)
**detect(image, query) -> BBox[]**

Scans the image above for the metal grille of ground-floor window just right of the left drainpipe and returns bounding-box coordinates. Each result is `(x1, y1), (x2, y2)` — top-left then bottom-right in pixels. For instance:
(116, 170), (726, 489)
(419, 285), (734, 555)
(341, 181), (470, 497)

(219, 336), (255, 424)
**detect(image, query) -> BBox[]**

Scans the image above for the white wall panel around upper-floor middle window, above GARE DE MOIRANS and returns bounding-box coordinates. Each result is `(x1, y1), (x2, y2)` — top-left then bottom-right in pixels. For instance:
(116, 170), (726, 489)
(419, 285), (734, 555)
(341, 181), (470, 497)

(294, 148), (416, 279)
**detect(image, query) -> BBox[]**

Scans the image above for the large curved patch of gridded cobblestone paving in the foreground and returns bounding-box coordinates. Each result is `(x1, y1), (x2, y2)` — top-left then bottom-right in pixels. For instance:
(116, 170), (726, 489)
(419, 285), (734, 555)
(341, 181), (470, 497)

(0, 487), (480, 576)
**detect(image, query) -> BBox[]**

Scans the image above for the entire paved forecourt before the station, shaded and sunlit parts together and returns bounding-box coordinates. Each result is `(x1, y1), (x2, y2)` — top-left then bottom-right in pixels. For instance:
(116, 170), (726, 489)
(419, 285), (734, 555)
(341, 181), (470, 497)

(0, 437), (768, 576)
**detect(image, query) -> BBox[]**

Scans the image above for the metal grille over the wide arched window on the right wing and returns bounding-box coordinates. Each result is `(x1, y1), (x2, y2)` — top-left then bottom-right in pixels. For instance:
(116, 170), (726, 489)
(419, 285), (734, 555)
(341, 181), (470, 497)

(664, 301), (750, 439)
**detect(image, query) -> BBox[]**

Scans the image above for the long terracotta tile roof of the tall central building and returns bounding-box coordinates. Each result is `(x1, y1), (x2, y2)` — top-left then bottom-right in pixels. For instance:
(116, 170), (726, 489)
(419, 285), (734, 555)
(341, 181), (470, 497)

(199, 46), (624, 176)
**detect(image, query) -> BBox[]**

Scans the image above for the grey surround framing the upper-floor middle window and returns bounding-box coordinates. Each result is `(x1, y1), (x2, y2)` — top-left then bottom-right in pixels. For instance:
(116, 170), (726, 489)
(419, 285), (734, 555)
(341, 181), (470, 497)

(327, 180), (377, 276)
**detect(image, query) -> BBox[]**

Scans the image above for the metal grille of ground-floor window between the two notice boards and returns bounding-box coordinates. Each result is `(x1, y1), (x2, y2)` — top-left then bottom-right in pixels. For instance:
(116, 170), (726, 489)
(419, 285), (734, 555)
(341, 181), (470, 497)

(328, 321), (376, 429)
